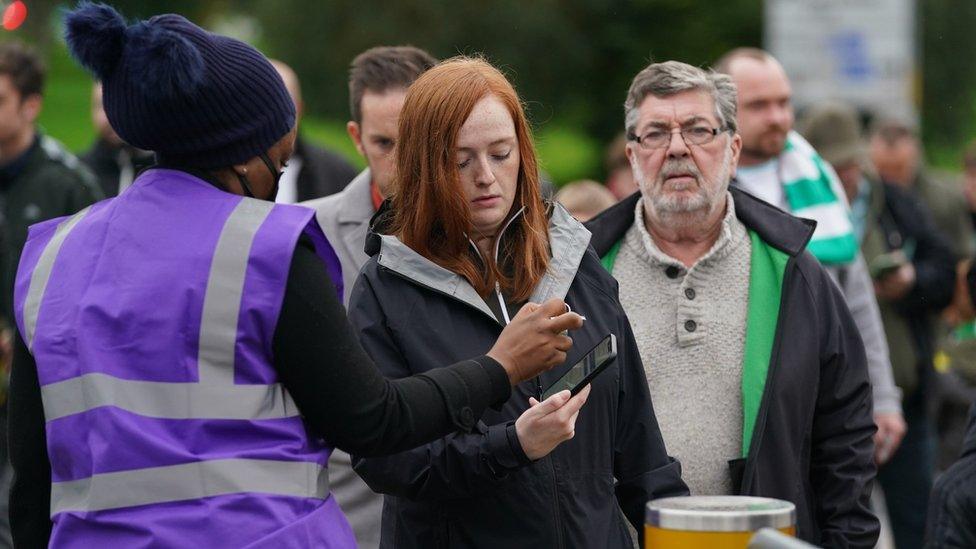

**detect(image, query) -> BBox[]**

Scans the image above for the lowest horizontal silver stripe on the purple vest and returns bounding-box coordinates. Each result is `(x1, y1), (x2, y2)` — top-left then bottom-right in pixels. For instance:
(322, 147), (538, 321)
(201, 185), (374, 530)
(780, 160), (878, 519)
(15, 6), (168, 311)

(51, 459), (329, 516)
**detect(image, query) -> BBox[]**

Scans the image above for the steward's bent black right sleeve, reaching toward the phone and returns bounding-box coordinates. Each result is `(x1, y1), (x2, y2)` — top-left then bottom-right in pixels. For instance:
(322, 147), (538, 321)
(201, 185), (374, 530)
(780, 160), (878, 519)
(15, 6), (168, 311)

(272, 242), (511, 457)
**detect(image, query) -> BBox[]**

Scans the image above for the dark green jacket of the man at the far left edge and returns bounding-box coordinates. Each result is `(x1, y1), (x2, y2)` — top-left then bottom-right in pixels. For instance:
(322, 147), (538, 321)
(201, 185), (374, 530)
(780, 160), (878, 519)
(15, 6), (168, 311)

(0, 134), (103, 318)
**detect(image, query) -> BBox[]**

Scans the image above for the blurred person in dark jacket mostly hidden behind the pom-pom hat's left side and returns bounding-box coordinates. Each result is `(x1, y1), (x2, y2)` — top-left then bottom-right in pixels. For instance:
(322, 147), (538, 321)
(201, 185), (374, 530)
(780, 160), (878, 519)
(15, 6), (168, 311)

(80, 82), (154, 198)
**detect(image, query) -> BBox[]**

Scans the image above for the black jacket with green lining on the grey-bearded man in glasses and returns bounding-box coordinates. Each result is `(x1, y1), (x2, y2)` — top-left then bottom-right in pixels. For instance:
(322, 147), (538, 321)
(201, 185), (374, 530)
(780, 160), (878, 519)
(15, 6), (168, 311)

(586, 188), (879, 548)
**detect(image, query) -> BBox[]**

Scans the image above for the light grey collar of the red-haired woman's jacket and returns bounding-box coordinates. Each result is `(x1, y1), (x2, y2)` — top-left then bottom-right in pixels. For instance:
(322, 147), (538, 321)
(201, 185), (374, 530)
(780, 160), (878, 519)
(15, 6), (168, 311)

(366, 204), (590, 320)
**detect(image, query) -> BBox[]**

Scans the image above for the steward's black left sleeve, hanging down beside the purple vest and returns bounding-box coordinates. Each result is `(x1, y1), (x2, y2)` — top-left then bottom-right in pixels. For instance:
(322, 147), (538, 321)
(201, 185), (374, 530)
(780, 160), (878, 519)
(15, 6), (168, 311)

(7, 335), (51, 548)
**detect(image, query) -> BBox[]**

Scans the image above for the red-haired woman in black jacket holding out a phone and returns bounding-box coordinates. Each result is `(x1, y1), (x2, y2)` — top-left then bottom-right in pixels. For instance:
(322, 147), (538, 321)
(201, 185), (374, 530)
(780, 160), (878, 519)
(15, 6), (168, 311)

(350, 58), (687, 549)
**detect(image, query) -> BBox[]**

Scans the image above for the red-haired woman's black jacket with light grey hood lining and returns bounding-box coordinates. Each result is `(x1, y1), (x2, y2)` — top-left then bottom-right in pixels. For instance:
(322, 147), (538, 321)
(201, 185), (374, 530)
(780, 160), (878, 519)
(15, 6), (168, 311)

(349, 201), (687, 549)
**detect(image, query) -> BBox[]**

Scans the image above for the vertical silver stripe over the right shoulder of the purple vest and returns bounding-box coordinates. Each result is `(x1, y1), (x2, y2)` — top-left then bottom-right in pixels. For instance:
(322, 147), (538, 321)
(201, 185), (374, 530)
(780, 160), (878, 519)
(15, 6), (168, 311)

(197, 198), (274, 385)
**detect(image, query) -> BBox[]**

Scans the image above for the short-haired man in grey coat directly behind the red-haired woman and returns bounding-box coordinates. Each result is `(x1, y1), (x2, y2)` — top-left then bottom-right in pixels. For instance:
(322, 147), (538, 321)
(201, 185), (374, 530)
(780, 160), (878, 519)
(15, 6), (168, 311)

(303, 46), (437, 549)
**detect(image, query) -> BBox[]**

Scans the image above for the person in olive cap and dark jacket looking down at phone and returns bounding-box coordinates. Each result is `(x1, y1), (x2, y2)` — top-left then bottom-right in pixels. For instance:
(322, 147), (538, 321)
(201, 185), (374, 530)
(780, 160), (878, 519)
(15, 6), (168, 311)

(798, 102), (952, 547)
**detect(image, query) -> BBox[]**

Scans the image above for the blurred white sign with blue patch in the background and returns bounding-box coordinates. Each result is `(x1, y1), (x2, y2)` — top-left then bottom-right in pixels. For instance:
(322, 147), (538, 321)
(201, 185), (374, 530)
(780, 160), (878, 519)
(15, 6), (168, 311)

(764, 0), (920, 121)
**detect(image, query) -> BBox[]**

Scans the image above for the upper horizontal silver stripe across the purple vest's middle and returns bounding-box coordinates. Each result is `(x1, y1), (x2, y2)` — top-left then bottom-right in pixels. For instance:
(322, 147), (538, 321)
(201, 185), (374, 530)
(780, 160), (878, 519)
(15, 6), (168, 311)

(41, 374), (299, 421)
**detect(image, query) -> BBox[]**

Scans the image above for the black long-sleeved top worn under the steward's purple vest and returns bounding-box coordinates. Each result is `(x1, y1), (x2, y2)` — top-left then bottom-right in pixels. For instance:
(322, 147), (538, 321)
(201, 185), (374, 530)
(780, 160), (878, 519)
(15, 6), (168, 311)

(8, 240), (511, 548)
